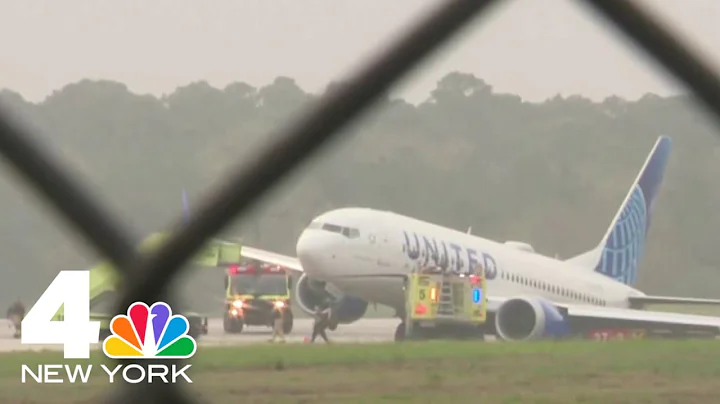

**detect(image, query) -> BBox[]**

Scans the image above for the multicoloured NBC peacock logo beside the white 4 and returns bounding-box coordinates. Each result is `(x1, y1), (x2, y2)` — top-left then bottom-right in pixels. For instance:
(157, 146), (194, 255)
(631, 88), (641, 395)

(103, 302), (197, 359)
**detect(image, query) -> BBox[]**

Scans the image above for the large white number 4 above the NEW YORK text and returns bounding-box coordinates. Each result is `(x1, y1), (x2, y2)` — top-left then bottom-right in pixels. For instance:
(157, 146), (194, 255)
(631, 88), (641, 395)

(21, 271), (100, 359)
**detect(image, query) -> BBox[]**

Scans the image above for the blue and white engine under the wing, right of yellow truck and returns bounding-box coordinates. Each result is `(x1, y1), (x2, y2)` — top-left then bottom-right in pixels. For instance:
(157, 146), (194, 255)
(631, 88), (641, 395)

(495, 297), (570, 341)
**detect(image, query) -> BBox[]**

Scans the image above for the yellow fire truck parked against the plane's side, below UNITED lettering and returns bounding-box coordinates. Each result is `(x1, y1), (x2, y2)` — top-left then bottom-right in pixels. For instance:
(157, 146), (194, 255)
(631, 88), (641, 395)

(395, 266), (487, 341)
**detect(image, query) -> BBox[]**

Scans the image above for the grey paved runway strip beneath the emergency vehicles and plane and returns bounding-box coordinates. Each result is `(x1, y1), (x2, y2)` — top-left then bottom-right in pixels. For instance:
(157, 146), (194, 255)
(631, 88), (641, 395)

(0, 318), (399, 352)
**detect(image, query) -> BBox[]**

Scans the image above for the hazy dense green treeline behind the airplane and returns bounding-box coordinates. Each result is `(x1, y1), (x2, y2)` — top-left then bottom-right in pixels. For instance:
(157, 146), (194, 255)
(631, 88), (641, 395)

(0, 72), (720, 309)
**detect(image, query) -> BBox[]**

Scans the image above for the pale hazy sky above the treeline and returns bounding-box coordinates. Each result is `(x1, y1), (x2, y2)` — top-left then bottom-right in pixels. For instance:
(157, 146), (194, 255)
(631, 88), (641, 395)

(0, 0), (720, 101)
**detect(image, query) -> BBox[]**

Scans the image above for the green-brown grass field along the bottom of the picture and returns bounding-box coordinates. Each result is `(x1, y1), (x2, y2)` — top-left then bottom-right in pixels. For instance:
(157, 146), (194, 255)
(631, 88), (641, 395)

(0, 340), (720, 404)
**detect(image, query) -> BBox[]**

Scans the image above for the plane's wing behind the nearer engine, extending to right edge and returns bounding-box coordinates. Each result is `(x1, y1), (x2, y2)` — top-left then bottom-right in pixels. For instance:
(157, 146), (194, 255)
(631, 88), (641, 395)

(488, 297), (720, 334)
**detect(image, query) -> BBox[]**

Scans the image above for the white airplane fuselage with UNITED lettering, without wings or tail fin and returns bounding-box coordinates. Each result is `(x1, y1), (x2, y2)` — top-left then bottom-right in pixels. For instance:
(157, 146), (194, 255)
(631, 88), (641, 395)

(297, 208), (644, 309)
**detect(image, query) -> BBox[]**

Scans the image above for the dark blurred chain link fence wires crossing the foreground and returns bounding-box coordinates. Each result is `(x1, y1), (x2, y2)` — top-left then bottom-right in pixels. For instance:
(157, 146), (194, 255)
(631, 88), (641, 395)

(0, 0), (720, 404)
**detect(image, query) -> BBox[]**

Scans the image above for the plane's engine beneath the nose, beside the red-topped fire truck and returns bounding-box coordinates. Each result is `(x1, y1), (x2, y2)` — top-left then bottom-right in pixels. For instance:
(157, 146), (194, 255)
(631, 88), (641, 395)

(295, 274), (368, 329)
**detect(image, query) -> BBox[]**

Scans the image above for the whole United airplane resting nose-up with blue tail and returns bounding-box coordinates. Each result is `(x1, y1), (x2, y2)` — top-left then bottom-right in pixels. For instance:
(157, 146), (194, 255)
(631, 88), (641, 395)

(231, 136), (720, 341)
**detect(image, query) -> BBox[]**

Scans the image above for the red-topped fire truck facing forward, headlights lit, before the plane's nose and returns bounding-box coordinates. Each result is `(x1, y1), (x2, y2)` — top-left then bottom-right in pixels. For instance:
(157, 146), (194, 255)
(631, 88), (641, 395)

(223, 261), (293, 334)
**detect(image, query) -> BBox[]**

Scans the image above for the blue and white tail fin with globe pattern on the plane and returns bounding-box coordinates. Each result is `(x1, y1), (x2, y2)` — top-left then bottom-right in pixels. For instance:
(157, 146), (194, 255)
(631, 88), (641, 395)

(567, 136), (672, 285)
